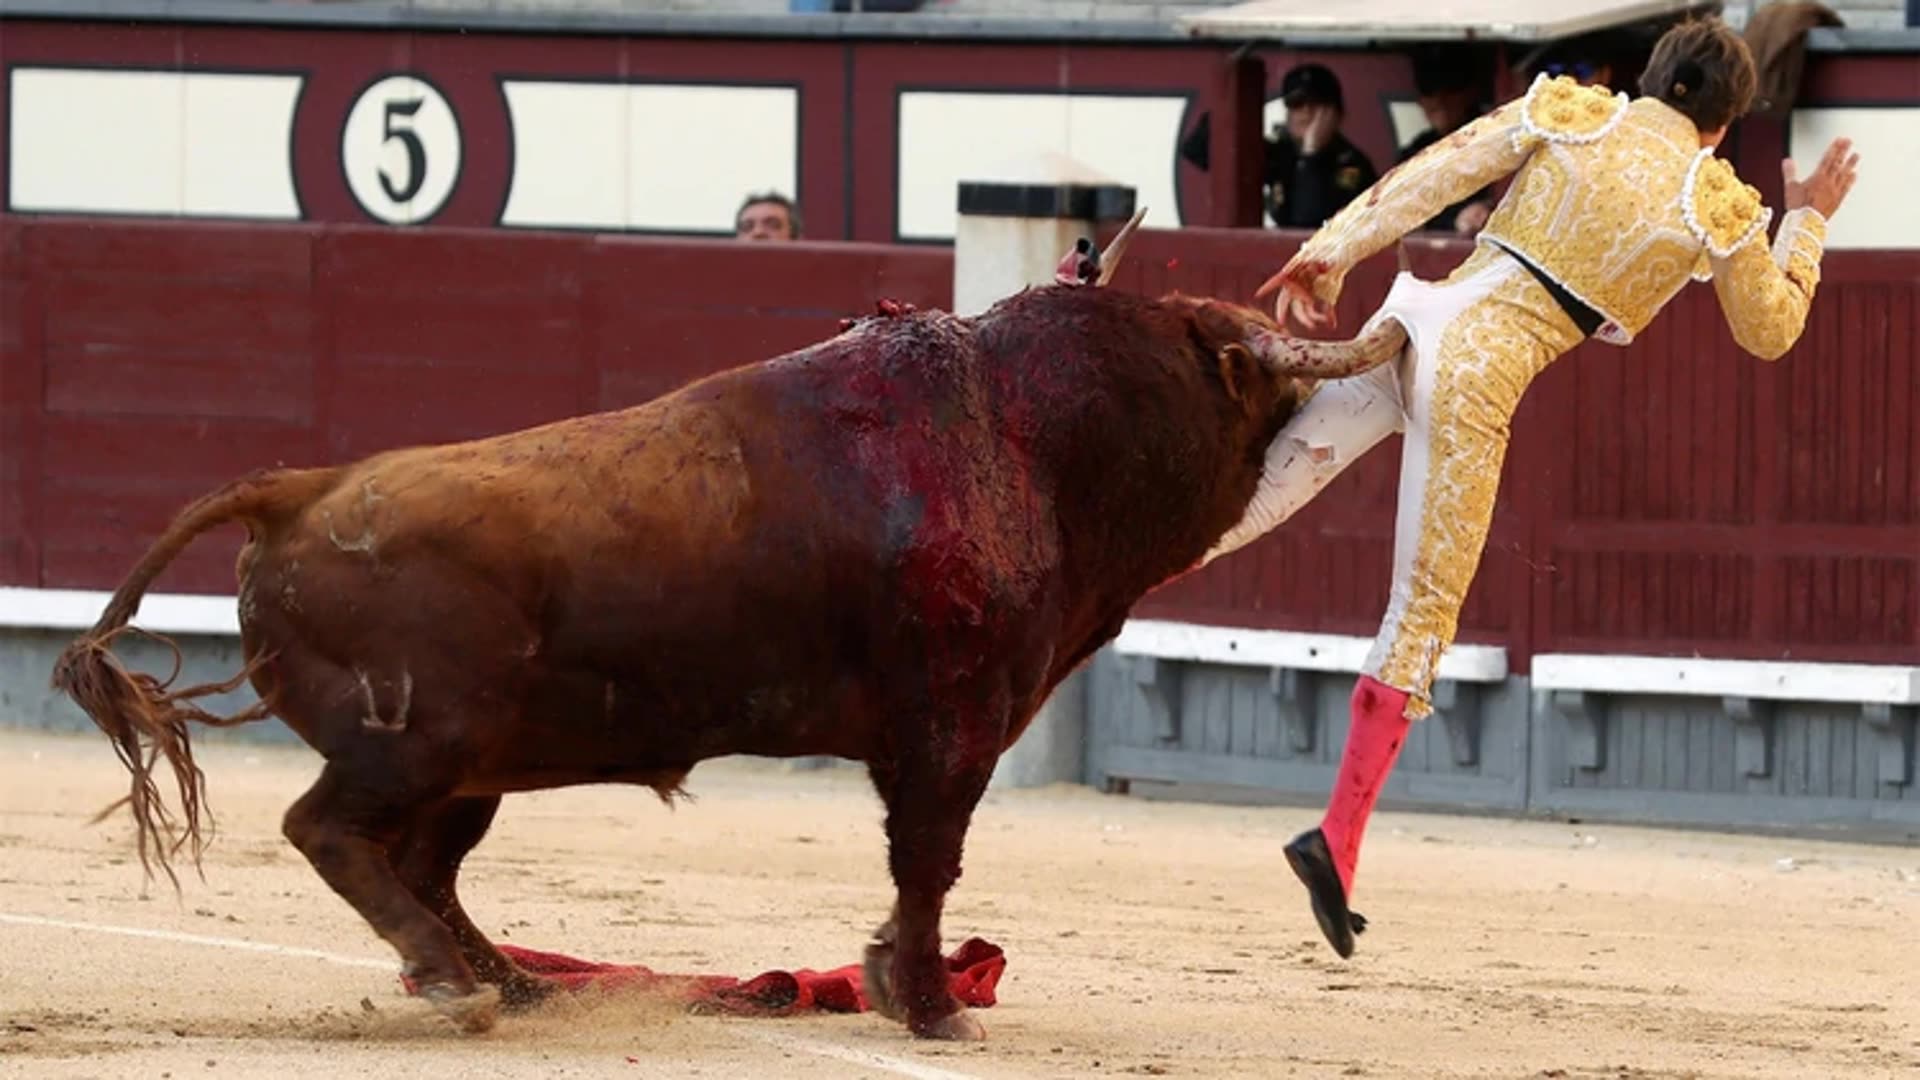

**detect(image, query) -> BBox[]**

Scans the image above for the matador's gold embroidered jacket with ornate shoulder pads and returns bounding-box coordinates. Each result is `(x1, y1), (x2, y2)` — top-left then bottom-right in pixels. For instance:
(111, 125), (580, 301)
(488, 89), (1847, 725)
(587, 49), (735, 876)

(1296, 75), (1826, 359)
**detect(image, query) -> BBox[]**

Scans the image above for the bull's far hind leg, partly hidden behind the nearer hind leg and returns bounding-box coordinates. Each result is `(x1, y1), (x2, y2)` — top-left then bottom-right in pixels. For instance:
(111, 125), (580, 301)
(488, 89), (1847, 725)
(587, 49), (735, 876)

(392, 796), (559, 1009)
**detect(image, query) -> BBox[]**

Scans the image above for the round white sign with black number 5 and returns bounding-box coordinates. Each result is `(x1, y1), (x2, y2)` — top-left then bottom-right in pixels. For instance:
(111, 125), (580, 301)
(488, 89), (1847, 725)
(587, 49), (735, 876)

(340, 75), (461, 225)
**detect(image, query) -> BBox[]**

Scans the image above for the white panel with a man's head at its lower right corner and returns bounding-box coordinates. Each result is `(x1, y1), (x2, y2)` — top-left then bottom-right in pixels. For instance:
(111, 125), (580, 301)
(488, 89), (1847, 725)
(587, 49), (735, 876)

(501, 79), (801, 233)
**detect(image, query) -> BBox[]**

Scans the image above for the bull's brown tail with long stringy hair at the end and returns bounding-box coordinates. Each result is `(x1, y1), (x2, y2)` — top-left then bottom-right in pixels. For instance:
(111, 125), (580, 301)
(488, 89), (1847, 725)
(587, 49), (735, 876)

(52, 469), (336, 890)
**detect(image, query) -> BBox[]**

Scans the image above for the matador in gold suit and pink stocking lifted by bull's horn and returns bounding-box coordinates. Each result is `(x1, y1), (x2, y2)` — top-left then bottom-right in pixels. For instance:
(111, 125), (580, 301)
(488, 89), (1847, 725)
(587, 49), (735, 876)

(1202, 19), (1859, 957)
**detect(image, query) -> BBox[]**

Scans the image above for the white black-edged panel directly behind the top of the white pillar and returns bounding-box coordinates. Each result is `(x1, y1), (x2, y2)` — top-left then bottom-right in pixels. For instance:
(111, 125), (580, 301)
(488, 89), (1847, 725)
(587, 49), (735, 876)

(895, 90), (1187, 240)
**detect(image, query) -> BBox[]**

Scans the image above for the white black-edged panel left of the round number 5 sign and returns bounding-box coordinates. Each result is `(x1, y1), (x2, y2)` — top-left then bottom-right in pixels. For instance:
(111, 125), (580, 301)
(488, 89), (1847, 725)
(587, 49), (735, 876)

(8, 67), (301, 221)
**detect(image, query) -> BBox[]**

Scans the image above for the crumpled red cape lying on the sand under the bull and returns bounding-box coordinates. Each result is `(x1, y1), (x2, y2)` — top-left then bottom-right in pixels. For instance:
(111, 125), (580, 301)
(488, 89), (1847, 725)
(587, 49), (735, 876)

(399, 938), (1006, 1017)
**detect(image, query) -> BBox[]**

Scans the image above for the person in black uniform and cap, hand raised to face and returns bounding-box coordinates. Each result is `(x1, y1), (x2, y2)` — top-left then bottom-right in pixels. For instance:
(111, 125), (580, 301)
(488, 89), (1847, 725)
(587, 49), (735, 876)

(1265, 63), (1379, 229)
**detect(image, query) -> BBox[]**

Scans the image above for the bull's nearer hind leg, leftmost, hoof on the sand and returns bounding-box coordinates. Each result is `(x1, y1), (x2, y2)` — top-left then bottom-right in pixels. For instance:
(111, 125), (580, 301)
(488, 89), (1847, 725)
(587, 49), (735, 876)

(282, 761), (499, 1032)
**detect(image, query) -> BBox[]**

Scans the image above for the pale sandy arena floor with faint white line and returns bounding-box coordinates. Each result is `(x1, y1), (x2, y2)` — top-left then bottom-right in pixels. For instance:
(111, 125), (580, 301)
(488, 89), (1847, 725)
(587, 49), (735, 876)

(0, 732), (1920, 1080)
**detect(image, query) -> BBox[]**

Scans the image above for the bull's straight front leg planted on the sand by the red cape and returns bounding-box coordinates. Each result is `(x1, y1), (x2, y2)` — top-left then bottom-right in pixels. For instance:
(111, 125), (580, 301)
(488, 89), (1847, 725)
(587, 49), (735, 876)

(866, 730), (1004, 1040)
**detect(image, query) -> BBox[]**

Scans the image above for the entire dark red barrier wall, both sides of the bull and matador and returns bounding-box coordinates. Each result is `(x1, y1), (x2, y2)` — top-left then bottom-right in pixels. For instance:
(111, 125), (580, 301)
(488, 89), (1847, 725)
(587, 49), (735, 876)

(0, 215), (1920, 671)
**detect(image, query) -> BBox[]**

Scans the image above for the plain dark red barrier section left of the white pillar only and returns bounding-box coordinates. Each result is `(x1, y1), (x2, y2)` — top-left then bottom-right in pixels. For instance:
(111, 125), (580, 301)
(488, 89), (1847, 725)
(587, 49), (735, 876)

(0, 215), (952, 592)
